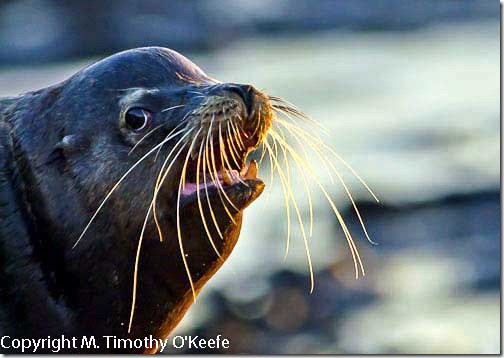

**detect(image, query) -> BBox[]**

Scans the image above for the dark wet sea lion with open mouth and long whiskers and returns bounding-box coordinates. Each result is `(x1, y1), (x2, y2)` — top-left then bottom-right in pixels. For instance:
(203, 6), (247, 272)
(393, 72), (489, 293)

(0, 47), (272, 353)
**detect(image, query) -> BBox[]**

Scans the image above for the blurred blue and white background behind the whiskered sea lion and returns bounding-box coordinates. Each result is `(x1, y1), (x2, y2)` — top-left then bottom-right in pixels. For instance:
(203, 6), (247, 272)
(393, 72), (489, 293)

(0, 0), (501, 354)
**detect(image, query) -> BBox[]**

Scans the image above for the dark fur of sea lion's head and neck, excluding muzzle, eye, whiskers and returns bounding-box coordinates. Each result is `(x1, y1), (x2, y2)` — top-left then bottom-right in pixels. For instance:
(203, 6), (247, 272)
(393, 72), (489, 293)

(0, 47), (271, 353)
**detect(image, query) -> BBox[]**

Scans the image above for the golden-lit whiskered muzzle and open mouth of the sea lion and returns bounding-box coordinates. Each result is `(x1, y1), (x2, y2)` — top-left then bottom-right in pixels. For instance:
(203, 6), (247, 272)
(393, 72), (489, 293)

(180, 91), (271, 204)
